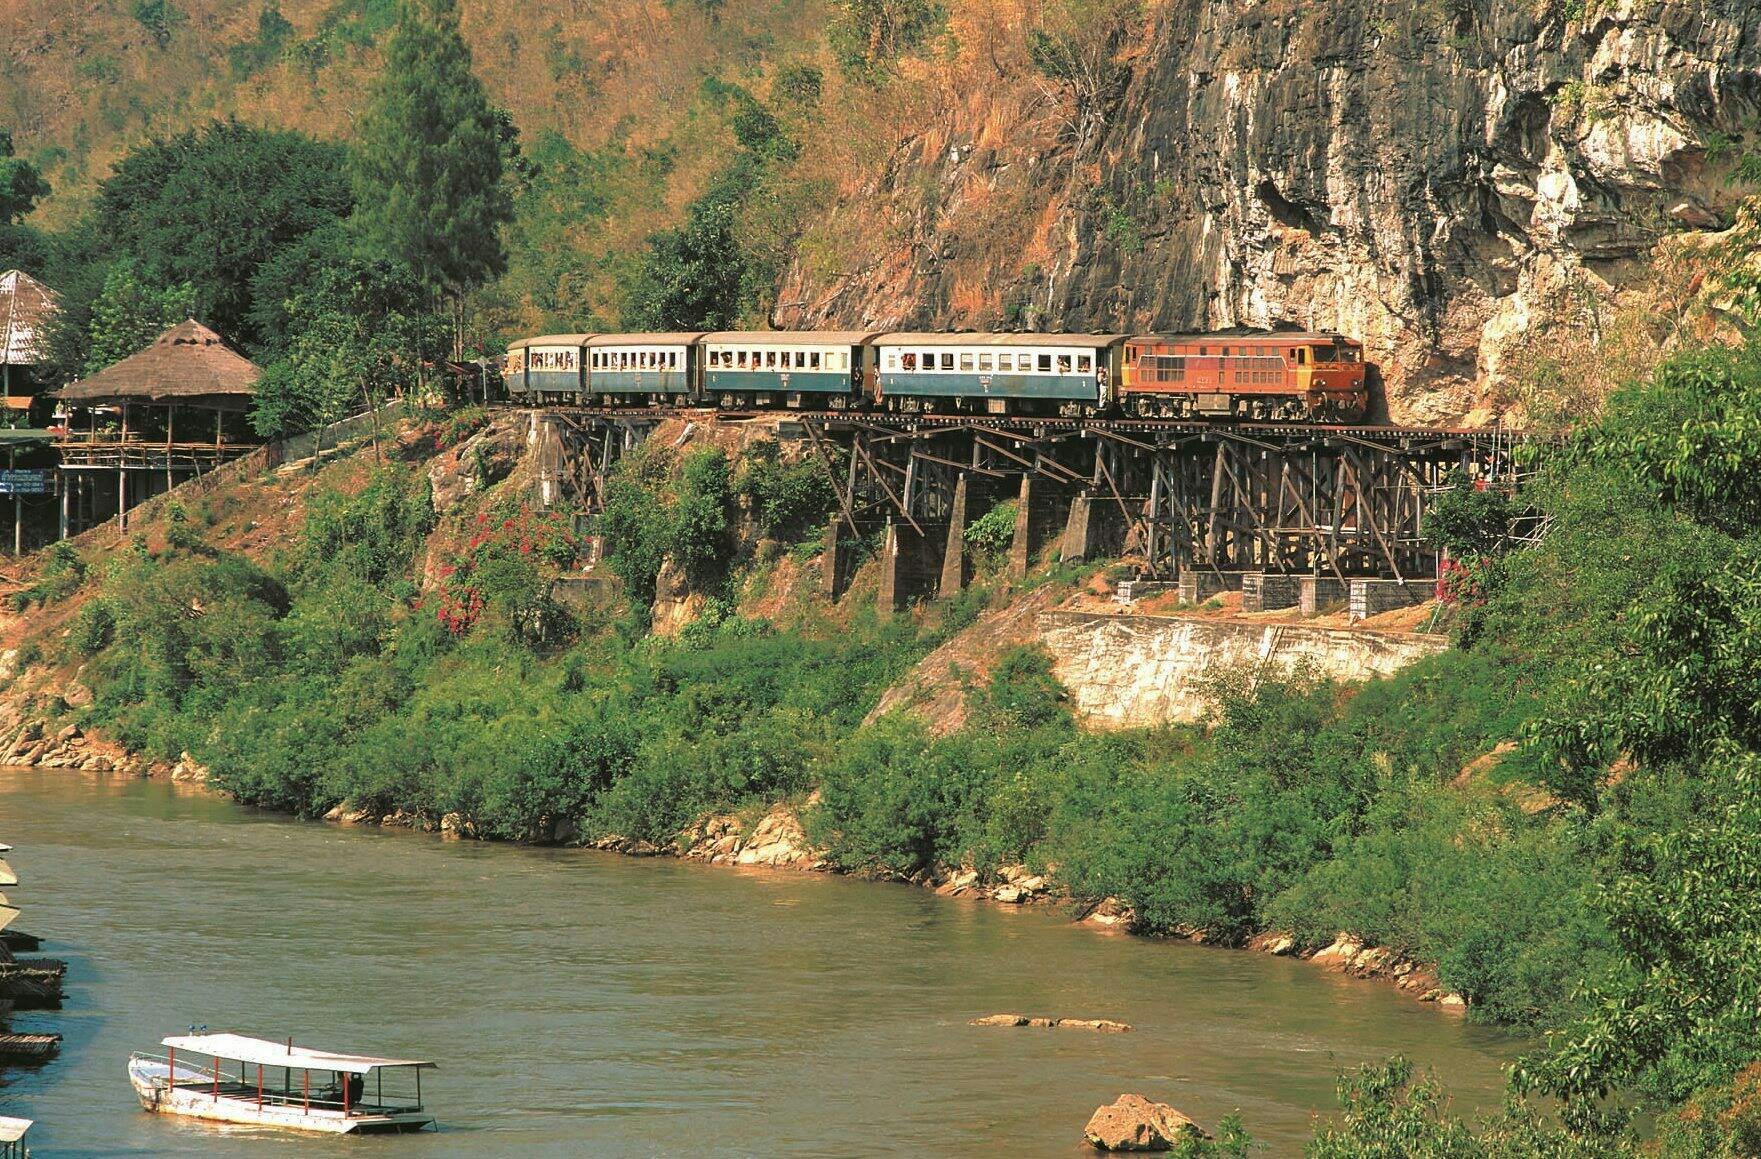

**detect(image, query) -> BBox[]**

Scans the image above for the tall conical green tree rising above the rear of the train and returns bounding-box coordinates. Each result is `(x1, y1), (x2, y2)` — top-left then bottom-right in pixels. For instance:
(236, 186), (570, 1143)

(354, 0), (512, 356)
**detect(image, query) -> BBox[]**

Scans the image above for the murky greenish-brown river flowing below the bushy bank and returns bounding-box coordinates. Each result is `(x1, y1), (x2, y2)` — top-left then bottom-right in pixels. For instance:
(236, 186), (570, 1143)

(0, 770), (1522, 1159)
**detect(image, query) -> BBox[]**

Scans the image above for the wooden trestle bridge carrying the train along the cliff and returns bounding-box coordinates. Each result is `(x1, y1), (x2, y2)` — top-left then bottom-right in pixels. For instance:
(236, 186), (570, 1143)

(532, 409), (1523, 608)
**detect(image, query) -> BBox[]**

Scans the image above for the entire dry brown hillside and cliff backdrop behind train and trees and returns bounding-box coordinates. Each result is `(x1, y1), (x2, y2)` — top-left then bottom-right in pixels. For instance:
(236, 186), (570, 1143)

(0, 0), (1761, 421)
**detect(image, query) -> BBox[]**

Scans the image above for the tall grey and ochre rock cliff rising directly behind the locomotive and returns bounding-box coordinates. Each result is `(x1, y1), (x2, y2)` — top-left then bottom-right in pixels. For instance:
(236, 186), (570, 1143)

(780, 0), (1761, 421)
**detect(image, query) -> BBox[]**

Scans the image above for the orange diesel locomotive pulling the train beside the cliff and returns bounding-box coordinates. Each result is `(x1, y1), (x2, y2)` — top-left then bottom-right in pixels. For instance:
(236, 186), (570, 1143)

(1116, 331), (1370, 423)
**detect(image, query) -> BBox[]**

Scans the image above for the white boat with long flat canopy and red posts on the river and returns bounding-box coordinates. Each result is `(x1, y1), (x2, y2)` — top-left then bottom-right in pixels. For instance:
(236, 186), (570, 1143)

(129, 1034), (435, 1134)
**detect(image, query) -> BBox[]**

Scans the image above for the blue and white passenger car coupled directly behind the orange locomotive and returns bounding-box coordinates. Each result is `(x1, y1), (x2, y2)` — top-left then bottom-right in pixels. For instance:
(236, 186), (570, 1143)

(873, 333), (1125, 416)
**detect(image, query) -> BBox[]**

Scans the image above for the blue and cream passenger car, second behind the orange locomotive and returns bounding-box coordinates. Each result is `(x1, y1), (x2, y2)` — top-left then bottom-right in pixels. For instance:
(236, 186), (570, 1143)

(701, 329), (875, 409)
